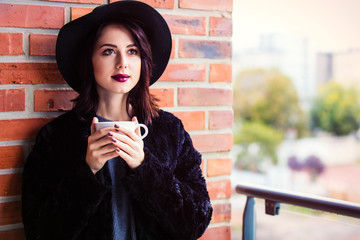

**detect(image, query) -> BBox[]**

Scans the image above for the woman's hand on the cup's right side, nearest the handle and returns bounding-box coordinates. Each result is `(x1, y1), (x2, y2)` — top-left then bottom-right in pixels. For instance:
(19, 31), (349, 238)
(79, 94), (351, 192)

(112, 117), (145, 169)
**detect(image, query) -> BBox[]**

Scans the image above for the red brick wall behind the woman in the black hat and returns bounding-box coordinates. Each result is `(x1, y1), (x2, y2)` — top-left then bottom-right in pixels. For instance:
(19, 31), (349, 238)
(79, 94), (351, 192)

(0, 0), (233, 240)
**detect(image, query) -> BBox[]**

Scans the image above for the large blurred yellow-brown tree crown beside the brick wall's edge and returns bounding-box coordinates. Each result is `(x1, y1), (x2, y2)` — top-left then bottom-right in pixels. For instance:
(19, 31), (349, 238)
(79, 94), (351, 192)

(234, 69), (307, 135)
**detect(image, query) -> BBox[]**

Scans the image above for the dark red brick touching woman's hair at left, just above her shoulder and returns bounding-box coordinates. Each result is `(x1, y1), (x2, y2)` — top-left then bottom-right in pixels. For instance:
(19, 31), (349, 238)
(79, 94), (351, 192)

(34, 90), (78, 112)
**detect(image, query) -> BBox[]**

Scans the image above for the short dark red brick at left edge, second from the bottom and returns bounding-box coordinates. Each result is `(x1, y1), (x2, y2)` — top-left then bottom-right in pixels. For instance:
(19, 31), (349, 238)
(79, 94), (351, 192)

(0, 201), (22, 226)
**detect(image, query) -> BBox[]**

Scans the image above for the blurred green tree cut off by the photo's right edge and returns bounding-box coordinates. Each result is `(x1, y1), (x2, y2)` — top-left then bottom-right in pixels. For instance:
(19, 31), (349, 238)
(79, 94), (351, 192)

(311, 82), (360, 136)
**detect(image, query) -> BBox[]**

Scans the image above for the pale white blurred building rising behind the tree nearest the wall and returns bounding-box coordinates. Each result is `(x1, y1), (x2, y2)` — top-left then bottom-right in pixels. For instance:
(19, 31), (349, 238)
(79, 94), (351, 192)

(234, 33), (317, 110)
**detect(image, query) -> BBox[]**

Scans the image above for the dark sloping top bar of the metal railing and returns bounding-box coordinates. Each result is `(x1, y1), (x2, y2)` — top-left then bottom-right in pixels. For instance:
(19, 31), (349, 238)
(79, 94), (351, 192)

(236, 184), (360, 218)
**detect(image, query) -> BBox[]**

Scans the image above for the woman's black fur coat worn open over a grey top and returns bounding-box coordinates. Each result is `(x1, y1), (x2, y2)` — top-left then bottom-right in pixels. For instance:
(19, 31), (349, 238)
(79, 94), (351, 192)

(22, 111), (212, 240)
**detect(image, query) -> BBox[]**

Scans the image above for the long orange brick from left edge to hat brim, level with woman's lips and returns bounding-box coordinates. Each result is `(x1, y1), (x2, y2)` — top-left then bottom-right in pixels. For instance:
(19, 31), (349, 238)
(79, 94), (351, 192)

(0, 63), (65, 84)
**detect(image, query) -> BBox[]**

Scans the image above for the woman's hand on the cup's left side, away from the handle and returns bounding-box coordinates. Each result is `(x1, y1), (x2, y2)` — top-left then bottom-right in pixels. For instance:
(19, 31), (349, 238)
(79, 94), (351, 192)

(86, 117), (119, 174)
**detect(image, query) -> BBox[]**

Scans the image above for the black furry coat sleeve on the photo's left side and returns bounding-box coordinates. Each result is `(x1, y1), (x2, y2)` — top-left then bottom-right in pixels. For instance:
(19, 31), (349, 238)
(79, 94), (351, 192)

(22, 124), (108, 240)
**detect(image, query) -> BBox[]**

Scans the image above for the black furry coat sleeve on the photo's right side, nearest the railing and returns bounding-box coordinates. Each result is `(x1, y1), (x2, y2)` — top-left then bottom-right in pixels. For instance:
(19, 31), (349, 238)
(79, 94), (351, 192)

(128, 115), (212, 239)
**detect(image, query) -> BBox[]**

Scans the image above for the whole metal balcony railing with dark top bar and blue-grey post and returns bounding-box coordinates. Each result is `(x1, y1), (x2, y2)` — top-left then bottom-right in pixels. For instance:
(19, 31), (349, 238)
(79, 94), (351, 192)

(235, 183), (360, 240)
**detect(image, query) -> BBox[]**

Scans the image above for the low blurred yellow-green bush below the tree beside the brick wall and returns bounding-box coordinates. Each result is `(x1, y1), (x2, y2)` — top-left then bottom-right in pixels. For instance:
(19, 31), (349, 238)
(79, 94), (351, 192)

(234, 121), (284, 168)
